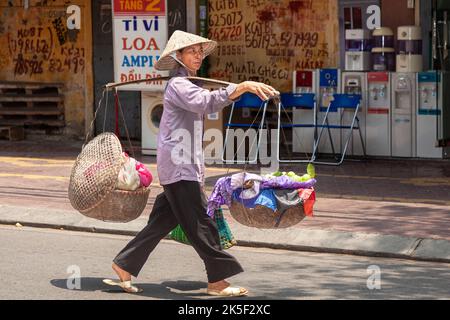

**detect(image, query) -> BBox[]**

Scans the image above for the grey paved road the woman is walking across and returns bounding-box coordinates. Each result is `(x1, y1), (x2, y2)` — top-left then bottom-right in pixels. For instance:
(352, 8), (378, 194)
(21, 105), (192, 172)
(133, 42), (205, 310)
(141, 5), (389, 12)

(0, 226), (450, 300)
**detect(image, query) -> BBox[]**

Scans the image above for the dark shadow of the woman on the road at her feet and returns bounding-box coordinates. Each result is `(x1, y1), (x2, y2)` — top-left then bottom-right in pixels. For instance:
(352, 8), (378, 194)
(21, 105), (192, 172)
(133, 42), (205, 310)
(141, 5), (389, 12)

(50, 277), (220, 300)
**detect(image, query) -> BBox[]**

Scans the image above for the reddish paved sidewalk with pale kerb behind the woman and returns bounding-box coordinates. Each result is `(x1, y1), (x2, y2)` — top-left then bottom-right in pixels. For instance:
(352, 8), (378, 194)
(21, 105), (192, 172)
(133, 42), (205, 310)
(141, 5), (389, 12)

(0, 141), (450, 263)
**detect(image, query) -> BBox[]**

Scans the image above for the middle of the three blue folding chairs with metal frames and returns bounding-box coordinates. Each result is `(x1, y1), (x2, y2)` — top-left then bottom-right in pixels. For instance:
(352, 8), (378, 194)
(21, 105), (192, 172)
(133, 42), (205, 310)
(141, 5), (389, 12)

(277, 93), (317, 163)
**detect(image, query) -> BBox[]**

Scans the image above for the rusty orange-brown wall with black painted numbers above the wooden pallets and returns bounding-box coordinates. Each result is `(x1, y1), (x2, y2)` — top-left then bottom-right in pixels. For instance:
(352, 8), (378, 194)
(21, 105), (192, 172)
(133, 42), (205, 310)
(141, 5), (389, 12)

(0, 0), (93, 136)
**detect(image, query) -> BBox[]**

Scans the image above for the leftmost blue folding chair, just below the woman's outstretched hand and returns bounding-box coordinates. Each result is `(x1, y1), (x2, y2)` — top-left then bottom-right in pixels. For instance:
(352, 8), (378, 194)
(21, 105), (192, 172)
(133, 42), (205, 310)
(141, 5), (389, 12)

(222, 93), (268, 164)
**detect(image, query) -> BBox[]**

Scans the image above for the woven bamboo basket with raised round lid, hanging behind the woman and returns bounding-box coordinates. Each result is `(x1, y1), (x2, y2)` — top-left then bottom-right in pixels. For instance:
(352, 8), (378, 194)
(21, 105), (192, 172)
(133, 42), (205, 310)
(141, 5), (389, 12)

(69, 132), (150, 222)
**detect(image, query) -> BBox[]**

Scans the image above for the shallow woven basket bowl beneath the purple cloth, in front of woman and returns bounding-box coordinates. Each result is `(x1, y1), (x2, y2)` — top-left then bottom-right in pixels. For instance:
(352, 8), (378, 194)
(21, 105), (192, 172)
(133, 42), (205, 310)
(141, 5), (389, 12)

(230, 201), (305, 229)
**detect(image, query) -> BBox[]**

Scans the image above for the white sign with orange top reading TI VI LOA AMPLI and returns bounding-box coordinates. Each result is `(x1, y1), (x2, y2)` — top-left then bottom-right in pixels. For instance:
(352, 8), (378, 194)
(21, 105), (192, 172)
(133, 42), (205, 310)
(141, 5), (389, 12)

(112, 0), (168, 91)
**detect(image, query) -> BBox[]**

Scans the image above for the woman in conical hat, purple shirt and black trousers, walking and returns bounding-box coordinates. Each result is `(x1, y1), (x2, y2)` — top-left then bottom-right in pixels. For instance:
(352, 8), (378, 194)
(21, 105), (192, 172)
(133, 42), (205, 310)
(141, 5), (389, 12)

(109, 31), (279, 296)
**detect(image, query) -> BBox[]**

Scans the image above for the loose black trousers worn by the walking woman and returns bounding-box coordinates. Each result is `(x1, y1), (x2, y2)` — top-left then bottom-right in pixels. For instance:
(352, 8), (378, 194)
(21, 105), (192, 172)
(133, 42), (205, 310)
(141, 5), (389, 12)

(114, 181), (244, 282)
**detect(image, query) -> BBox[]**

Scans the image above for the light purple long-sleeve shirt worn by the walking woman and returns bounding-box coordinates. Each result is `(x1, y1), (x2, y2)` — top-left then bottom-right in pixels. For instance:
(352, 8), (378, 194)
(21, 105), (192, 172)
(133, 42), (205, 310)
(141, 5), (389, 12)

(157, 67), (236, 185)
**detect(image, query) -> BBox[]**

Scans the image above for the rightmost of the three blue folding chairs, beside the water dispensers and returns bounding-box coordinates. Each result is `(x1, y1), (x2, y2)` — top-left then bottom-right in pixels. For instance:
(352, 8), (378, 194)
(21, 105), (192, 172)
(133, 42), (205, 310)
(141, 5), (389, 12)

(311, 94), (366, 166)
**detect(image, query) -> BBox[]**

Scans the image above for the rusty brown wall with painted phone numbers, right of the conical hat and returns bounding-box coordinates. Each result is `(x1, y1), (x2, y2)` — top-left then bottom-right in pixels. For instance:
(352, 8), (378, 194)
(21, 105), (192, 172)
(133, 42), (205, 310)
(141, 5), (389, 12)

(208, 0), (339, 92)
